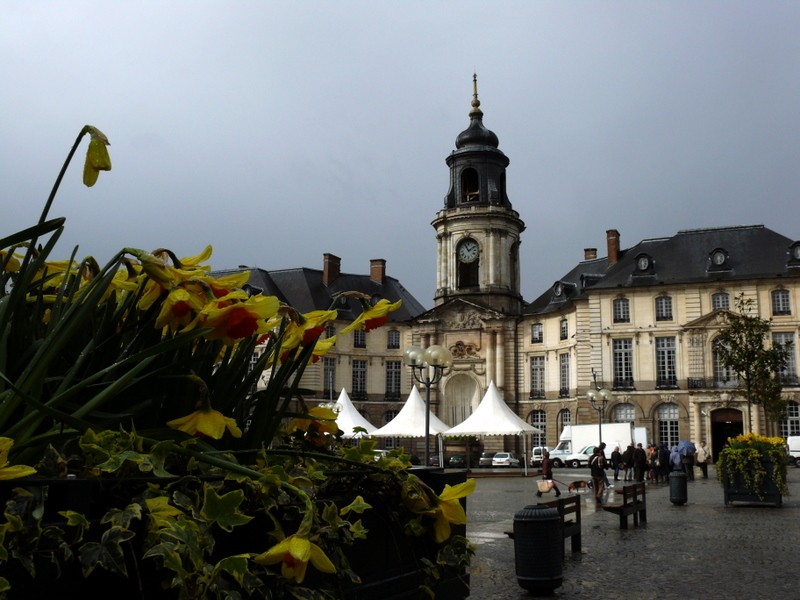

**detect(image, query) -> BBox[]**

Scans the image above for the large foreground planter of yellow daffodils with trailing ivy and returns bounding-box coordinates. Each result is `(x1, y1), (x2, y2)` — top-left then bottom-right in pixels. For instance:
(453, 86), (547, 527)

(0, 126), (474, 598)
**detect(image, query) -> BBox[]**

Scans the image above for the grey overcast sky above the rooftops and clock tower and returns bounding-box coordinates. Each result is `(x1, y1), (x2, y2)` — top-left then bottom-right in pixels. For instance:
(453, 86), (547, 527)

(0, 0), (800, 307)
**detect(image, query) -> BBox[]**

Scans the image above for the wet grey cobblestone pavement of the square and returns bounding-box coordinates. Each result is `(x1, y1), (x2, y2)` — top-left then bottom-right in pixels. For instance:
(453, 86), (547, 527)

(467, 467), (800, 600)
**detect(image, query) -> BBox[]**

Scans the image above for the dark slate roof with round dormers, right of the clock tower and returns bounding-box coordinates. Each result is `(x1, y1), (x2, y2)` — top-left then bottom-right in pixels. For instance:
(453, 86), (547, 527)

(523, 225), (800, 315)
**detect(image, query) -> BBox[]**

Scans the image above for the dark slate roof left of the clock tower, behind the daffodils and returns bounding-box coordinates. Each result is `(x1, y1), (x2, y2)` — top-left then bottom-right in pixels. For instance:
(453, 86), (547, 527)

(213, 267), (425, 322)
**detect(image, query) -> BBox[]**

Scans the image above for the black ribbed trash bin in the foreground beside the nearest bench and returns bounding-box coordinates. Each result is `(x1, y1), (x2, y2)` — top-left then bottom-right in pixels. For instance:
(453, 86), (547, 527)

(514, 505), (564, 594)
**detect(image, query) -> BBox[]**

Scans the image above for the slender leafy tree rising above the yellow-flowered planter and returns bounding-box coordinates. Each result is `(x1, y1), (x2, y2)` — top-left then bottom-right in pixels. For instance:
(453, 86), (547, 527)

(716, 294), (789, 431)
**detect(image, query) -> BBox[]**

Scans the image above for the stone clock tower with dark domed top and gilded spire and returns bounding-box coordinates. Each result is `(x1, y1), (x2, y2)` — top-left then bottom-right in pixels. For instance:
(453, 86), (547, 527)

(432, 75), (525, 314)
